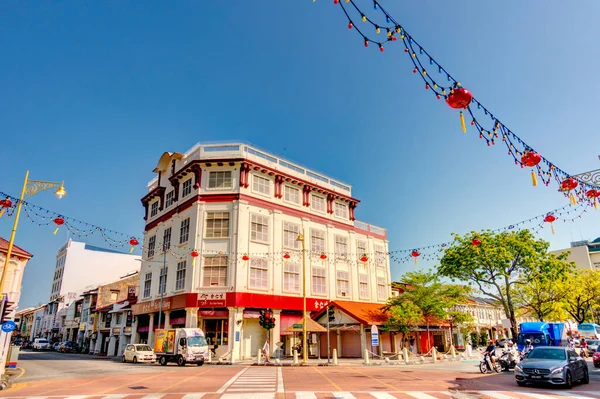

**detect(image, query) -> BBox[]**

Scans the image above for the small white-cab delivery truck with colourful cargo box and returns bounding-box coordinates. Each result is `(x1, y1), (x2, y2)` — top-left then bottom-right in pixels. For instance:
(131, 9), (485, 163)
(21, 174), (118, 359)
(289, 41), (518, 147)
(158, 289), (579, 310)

(154, 328), (208, 366)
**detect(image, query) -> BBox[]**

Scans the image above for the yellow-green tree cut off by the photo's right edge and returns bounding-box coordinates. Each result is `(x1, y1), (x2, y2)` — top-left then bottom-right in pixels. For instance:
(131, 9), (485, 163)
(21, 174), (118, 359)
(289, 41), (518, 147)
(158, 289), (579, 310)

(562, 270), (600, 323)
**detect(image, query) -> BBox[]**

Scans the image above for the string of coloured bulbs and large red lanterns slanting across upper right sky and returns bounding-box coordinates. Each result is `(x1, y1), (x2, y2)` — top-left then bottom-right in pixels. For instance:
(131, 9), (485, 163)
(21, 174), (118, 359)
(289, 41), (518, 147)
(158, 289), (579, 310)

(333, 0), (600, 209)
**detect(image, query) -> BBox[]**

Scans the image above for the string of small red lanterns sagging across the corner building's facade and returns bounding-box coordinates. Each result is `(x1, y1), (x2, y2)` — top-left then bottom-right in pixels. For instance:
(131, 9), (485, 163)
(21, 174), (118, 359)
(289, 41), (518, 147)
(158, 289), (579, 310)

(0, 192), (589, 264)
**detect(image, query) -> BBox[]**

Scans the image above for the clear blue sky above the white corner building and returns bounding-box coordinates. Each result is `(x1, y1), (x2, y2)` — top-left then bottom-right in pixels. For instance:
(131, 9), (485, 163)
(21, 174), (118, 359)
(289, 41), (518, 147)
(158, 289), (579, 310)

(0, 0), (600, 306)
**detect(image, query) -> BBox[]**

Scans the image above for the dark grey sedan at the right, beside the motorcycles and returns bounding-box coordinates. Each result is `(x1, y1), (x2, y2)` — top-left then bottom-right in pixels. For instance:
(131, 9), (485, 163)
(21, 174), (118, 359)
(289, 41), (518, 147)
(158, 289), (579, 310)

(515, 346), (590, 388)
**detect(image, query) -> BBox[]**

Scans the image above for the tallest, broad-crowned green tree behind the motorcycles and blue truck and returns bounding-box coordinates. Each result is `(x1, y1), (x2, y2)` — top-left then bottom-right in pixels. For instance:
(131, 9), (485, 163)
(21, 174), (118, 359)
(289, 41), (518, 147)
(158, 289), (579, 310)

(438, 230), (572, 340)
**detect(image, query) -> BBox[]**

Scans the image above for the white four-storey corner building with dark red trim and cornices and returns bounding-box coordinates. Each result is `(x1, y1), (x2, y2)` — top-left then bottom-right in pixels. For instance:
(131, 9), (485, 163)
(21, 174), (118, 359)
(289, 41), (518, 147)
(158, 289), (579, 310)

(132, 144), (390, 361)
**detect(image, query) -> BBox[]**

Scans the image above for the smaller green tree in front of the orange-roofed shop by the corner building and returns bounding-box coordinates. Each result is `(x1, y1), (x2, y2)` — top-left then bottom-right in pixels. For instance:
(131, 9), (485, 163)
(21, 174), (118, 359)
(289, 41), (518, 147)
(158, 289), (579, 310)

(385, 271), (470, 354)
